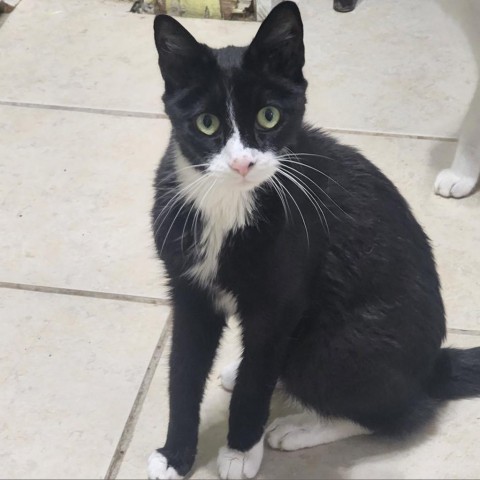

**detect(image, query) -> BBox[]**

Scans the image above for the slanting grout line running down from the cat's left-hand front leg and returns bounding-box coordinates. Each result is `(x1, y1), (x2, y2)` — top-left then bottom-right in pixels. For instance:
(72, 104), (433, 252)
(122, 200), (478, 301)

(104, 312), (172, 480)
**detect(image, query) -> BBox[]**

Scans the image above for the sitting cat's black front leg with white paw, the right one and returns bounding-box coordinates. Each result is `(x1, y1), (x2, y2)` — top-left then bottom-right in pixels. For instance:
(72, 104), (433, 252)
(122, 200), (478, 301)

(217, 313), (293, 479)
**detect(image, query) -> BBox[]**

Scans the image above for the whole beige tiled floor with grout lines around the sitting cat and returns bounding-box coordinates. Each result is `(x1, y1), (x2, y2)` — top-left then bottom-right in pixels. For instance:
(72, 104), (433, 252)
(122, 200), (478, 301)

(0, 0), (480, 478)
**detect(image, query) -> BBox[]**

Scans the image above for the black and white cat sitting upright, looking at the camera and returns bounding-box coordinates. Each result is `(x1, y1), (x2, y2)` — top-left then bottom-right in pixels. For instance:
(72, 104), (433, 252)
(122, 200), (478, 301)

(148, 1), (480, 478)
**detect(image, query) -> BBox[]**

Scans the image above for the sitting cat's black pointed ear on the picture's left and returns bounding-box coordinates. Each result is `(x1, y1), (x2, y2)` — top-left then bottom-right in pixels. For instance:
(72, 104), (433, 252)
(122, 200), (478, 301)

(153, 15), (215, 93)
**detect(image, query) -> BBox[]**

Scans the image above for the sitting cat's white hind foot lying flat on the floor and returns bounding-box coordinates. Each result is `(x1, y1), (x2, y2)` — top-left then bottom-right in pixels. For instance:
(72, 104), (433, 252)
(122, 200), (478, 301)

(267, 412), (372, 450)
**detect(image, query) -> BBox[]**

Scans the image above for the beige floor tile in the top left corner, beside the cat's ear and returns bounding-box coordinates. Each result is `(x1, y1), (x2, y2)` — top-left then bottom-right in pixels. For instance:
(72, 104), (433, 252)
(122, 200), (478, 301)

(0, 0), (161, 112)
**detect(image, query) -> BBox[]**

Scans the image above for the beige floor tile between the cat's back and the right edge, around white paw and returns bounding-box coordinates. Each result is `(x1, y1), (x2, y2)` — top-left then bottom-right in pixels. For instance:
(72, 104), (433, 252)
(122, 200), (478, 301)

(334, 135), (480, 329)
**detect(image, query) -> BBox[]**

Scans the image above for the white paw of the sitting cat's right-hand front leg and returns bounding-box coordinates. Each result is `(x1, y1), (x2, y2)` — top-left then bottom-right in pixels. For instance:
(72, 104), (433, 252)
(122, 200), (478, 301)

(217, 437), (263, 480)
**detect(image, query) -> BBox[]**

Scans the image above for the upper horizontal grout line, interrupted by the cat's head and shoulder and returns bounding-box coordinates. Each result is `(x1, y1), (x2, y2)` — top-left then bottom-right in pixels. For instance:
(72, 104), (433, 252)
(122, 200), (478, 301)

(0, 100), (458, 142)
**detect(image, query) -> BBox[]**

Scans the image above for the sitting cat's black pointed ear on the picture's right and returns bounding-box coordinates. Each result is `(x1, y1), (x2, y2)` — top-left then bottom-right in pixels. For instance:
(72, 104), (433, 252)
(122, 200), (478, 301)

(243, 1), (305, 83)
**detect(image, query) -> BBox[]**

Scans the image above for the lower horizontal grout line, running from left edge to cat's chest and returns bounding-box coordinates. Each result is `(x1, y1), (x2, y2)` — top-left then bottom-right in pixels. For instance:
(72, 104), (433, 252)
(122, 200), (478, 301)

(0, 282), (170, 305)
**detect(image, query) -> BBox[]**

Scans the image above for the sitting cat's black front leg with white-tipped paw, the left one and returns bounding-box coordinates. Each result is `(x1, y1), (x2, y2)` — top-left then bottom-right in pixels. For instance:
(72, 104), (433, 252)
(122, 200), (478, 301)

(148, 288), (225, 479)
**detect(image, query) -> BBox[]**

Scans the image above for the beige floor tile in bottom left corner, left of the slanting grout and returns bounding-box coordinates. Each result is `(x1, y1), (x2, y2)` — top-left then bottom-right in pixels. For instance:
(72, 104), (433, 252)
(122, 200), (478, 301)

(0, 289), (168, 478)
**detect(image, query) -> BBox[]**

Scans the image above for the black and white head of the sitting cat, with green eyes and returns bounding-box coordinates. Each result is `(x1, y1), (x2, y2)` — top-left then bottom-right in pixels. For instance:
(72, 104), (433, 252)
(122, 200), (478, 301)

(154, 1), (307, 191)
